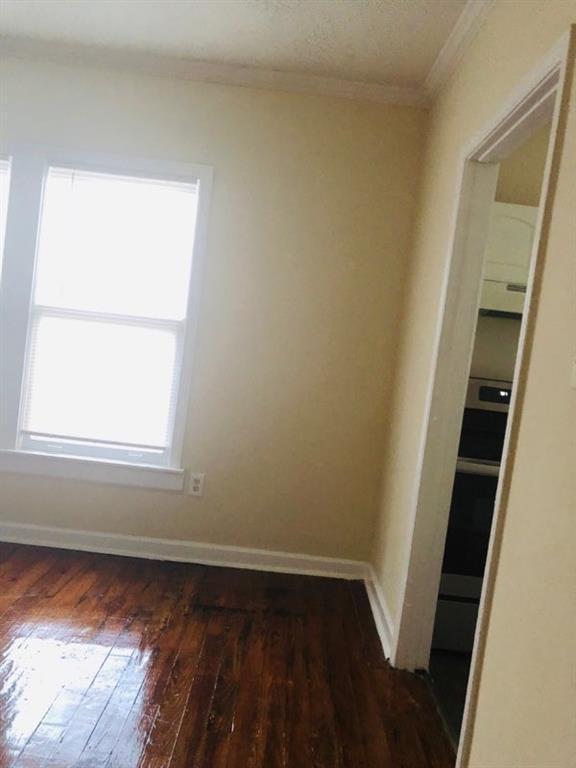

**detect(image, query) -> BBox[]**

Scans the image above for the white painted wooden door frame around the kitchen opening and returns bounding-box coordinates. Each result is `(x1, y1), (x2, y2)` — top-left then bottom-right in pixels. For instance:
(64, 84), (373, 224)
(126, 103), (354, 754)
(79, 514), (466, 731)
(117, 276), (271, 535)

(391, 30), (569, 768)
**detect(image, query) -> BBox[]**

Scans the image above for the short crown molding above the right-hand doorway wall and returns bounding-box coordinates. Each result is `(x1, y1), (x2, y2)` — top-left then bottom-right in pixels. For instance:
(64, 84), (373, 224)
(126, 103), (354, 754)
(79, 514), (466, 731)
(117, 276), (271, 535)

(422, 0), (494, 103)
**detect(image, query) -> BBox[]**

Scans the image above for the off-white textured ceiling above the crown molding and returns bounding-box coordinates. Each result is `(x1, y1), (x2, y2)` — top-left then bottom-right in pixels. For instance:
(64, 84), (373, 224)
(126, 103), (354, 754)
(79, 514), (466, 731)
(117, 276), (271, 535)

(0, 0), (466, 86)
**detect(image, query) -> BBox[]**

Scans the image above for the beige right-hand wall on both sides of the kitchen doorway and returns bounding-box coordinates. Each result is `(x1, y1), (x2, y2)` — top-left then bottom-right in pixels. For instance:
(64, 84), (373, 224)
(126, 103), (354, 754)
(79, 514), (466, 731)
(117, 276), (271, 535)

(373, 0), (576, 768)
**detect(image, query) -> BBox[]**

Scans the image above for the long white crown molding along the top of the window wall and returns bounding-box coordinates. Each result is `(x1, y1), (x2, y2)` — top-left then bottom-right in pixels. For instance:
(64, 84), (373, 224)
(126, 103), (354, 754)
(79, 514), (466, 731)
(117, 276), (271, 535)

(0, 36), (424, 106)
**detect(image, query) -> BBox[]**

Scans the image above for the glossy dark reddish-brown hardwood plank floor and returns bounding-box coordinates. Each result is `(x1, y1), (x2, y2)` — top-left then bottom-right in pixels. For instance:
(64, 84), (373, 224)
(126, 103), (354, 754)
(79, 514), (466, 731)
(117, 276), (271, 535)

(0, 544), (454, 768)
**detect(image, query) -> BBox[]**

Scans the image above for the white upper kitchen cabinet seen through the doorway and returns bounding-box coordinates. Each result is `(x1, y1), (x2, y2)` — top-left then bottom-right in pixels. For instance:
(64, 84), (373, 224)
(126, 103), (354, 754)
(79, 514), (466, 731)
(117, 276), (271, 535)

(480, 203), (538, 314)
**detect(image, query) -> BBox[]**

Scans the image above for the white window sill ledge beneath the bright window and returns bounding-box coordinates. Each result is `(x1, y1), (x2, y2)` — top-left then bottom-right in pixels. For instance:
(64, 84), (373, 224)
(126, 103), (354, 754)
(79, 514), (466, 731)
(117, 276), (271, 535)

(0, 450), (184, 491)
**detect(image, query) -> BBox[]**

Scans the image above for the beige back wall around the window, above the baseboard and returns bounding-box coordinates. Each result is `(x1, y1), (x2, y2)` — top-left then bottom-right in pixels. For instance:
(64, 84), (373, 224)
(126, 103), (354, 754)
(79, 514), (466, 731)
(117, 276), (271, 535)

(0, 54), (426, 559)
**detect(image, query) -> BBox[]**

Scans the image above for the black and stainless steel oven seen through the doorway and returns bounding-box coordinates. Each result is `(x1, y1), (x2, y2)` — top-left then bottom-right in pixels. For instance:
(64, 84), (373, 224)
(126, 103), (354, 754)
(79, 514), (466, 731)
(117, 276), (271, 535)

(432, 378), (512, 651)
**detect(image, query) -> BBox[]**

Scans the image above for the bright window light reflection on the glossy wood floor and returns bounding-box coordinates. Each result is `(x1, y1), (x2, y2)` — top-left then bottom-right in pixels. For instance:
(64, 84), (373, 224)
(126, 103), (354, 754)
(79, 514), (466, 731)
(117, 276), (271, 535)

(0, 616), (151, 767)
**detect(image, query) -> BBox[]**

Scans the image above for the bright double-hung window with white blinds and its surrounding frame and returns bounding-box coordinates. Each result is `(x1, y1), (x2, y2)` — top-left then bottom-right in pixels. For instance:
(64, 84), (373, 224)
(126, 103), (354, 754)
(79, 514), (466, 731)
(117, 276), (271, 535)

(0, 157), (209, 487)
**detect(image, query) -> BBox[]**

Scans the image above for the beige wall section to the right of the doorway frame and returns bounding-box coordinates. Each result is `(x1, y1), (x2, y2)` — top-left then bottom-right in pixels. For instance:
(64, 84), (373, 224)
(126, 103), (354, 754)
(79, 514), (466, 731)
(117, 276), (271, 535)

(471, 37), (576, 768)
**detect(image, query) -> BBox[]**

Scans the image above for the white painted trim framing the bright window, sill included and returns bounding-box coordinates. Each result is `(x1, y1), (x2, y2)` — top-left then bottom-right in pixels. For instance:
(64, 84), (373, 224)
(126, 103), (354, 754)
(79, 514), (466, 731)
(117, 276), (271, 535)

(0, 145), (213, 491)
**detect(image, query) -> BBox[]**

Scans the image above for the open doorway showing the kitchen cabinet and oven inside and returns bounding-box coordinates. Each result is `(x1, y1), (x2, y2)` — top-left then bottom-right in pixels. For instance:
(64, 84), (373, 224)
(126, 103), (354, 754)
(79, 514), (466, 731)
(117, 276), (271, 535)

(429, 122), (551, 745)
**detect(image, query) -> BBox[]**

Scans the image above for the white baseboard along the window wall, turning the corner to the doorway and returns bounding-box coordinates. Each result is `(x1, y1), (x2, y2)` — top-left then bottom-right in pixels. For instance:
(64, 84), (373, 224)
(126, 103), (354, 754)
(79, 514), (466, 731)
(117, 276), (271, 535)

(0, 521), (393, 658)
